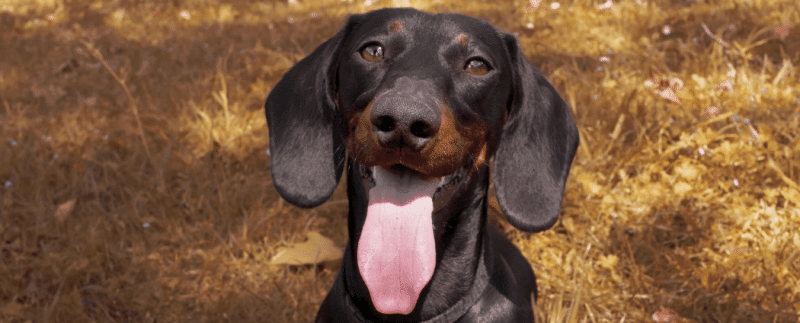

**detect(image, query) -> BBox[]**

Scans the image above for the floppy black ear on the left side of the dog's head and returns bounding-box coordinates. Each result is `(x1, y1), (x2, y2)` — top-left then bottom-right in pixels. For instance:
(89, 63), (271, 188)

(264, 24), (349, 208)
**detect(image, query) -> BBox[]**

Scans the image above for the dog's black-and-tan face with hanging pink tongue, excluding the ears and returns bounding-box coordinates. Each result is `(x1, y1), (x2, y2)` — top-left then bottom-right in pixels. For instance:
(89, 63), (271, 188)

(332, 10), (513, 314)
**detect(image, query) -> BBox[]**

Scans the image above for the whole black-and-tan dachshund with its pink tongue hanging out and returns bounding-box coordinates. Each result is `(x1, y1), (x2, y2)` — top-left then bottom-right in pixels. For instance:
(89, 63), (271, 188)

(265, 9), (578, 323)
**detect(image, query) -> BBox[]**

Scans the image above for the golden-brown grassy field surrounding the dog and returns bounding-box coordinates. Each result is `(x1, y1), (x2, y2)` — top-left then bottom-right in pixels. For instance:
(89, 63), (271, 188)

(0, 0), (800, 323)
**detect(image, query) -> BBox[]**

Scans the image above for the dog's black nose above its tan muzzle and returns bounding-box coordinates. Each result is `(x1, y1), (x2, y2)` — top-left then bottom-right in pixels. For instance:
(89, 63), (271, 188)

(370, 79), (441, 151)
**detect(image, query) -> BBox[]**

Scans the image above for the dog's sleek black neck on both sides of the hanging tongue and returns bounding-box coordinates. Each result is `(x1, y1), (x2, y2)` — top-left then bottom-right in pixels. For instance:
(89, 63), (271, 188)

(343, 165), (491, 321)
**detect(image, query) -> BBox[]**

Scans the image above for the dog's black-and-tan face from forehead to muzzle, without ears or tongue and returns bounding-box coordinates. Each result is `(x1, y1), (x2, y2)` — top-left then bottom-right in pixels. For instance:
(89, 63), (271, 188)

(335, 11), (512, 179)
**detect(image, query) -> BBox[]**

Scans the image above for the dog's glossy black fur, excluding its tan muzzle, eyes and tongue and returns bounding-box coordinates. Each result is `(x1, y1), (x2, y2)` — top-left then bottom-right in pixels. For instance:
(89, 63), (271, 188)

(265, 9), (578, 323)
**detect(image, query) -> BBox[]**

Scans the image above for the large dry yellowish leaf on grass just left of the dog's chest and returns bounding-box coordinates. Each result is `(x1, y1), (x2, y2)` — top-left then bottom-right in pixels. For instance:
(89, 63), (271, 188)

(271, 231), (342, 265)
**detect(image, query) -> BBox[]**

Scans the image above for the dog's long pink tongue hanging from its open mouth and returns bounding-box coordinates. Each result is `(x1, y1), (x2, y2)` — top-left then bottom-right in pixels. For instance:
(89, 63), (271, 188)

(357, 167), (437, 314)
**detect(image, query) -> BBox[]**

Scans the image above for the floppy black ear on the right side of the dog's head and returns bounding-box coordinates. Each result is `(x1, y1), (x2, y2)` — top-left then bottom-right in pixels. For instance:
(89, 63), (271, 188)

(494, 33), (578, 232)
